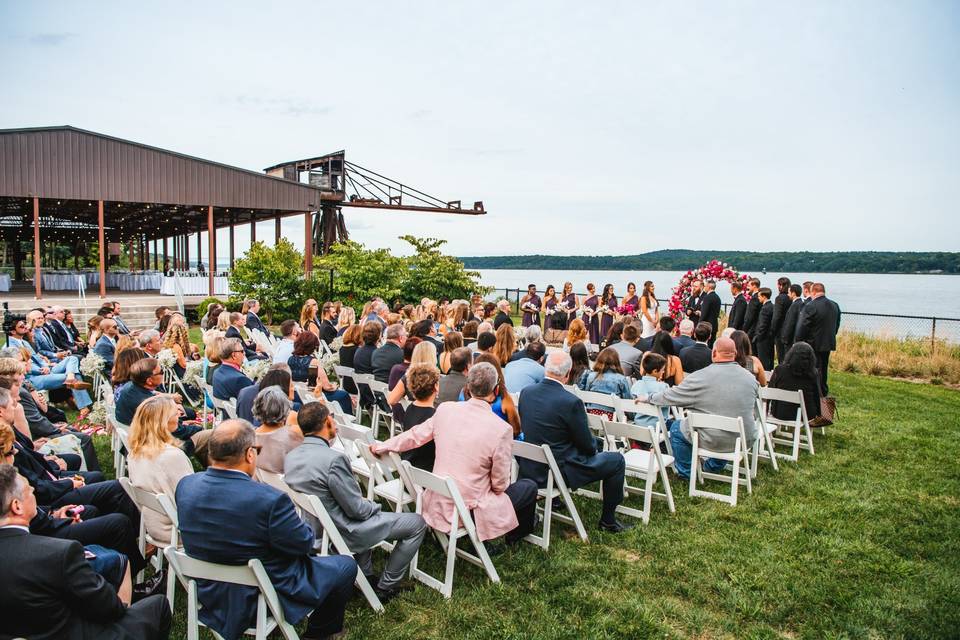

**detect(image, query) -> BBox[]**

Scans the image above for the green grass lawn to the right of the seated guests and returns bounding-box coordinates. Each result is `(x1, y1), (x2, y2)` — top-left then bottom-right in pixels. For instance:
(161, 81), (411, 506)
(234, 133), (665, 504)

(100, 373), (960, 639)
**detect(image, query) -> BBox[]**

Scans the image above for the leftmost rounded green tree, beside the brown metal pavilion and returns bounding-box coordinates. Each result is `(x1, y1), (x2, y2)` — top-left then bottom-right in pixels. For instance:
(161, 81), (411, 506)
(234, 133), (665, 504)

(230, 238), (303, 321)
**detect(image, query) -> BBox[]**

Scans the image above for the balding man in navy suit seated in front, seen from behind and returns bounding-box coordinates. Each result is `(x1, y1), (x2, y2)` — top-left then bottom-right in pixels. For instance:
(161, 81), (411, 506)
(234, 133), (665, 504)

(176, 420), (357, 640)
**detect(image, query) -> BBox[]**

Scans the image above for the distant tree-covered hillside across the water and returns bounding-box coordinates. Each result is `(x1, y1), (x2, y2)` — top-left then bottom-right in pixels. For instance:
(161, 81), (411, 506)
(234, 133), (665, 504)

(460, 249), (960, 273)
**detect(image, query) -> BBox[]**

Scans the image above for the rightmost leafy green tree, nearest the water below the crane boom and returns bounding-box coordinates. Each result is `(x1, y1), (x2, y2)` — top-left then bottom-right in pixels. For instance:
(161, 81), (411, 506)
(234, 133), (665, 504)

(400, 235), (490, 302)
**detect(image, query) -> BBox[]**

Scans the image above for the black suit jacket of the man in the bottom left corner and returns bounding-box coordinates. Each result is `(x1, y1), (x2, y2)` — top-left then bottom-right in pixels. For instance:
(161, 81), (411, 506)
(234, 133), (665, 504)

(0, 528), (129, 640)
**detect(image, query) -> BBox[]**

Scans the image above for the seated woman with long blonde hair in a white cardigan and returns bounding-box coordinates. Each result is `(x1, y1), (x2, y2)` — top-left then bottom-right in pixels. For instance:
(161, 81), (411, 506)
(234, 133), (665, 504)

(127, 396), (193, 543)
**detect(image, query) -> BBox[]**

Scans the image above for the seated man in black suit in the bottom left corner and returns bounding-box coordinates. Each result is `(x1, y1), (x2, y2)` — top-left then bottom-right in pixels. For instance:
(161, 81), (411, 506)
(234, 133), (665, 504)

(0, 464), (171, 640)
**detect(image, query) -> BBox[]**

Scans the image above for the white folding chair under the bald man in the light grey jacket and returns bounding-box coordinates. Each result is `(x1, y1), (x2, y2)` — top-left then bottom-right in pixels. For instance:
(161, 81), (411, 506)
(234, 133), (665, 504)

(687, 411), (753, 507)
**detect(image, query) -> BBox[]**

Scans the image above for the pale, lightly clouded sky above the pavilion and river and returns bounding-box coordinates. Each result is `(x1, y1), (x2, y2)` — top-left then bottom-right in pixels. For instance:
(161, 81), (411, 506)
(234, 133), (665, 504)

(0, 0), (960, 256)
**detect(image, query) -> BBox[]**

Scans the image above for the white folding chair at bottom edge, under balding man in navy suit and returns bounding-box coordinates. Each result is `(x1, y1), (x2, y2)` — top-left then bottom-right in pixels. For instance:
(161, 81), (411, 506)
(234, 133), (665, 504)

(163, 547), (299, 640)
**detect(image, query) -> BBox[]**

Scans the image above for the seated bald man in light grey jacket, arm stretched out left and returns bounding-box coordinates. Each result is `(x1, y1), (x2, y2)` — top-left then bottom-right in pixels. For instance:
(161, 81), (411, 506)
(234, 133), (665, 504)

(637, 331), (760, 479)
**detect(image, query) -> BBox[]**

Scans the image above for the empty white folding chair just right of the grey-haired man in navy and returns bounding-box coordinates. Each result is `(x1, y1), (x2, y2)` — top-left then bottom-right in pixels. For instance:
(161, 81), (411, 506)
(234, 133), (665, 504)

(603, 418), (676, 524)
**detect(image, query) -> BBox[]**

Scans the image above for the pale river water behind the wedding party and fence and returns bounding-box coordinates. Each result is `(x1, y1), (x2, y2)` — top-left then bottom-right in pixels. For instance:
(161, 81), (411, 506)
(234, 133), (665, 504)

(478, 269), (960, 342)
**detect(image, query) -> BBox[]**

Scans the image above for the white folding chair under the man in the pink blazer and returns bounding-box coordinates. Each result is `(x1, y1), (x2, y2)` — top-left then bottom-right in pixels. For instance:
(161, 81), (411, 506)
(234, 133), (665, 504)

(403, 461), (500, 598)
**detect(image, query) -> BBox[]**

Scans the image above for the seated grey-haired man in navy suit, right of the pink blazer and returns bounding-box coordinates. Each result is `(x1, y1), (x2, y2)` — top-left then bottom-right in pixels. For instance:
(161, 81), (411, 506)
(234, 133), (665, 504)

(518, 351), (631, 533)
